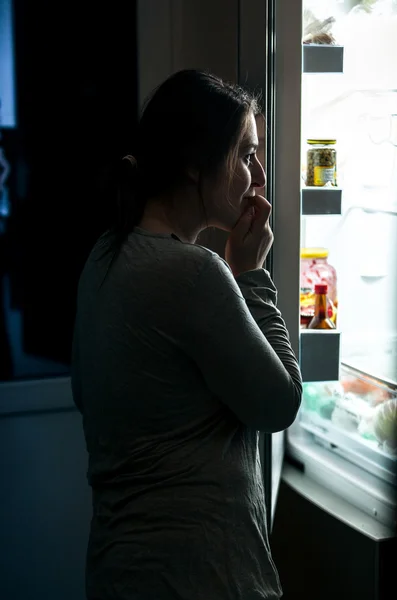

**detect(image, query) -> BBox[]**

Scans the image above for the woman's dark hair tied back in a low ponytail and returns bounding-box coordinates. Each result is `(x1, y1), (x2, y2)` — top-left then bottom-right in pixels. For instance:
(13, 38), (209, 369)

(106, 69), (260, 241)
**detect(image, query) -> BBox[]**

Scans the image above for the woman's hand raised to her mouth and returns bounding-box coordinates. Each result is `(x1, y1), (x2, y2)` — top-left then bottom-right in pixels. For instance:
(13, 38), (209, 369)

(225, 196), (274, 277)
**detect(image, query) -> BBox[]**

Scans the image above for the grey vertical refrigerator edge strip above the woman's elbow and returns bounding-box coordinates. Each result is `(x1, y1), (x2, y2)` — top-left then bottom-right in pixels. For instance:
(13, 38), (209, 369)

(273, 0), (302, 356)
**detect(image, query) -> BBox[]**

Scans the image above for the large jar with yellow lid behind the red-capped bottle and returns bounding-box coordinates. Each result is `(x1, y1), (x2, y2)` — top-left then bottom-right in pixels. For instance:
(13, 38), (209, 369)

(300, 248), (338, 328)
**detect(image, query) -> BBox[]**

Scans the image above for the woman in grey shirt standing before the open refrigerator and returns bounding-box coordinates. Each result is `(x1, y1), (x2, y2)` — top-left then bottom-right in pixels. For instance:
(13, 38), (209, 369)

(72, 70), (301, 600)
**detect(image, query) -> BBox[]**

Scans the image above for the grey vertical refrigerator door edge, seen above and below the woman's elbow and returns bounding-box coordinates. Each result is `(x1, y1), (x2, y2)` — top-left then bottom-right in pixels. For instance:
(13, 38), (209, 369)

(267, 0), (302, 528)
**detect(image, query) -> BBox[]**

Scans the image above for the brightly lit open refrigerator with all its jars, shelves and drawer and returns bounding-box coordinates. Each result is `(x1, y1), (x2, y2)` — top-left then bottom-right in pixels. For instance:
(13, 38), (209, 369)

(287, 0), (397, 527)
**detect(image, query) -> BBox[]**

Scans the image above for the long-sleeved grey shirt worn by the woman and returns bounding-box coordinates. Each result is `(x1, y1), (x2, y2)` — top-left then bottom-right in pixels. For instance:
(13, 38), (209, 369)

(72, 228), (301, 600)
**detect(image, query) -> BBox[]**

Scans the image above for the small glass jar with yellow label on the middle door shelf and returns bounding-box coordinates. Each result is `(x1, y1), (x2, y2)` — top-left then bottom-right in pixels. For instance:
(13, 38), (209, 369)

(306, 139), (337, 187)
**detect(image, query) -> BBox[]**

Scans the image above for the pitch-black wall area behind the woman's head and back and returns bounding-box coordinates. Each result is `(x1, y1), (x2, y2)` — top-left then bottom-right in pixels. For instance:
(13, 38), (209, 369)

(5, 0), (138, 362)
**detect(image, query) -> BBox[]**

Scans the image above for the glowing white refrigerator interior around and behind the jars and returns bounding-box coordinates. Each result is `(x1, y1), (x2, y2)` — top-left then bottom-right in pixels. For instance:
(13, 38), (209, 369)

(288, 0), (397, 520)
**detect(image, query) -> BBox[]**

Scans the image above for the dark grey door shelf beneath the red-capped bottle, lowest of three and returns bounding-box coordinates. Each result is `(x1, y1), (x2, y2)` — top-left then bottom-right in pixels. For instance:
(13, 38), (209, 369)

(299, 329), (340, 381)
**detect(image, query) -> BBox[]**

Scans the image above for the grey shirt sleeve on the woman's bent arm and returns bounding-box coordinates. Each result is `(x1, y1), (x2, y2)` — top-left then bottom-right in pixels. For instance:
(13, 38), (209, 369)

(178, 255), (302, 433)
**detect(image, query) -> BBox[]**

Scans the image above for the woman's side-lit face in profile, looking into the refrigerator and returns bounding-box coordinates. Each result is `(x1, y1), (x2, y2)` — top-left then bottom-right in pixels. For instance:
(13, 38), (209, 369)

(205, 113), (266, 231)
